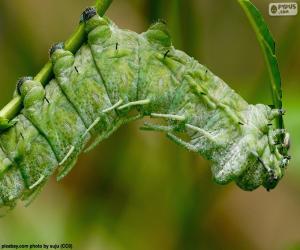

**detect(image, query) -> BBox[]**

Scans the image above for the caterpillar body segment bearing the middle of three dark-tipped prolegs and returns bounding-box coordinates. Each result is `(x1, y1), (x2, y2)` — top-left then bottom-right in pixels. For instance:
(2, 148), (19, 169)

(51, 41), (117, 139)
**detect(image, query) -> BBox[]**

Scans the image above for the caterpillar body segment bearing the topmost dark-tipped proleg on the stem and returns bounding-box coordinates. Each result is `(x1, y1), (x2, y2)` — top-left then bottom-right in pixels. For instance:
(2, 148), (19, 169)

(85, 10), (139, 110)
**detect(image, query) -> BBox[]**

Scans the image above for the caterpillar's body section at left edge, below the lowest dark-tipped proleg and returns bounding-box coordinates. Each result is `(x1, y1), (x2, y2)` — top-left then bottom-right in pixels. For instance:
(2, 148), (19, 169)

(0, 114), (58, 207)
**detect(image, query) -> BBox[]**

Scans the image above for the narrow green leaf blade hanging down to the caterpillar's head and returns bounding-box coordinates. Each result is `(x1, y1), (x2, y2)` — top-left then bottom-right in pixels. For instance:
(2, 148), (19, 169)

(238, 0), (283, 128)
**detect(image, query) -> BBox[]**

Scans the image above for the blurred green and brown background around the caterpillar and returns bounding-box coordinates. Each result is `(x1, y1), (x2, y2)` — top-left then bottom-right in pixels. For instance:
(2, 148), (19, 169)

(0, 0), (300, 250)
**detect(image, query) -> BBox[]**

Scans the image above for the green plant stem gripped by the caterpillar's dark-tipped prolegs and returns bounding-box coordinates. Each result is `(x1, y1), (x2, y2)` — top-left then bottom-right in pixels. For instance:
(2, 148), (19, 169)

(0, 0), (113, 121)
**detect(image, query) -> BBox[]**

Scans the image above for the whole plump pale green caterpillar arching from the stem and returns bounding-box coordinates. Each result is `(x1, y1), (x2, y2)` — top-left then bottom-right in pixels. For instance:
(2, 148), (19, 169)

(0, 8), (289, 207)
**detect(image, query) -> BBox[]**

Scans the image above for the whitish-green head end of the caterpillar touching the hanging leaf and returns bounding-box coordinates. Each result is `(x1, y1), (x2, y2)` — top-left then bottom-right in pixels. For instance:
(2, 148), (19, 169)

(236, 105), (291, 191)
